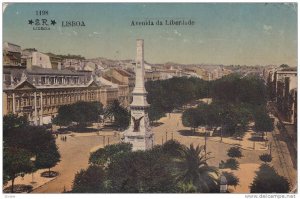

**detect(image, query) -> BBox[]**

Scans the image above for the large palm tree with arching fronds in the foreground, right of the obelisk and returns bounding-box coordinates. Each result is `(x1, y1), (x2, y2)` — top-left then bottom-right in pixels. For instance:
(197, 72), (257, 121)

(177, 144), (219, 193)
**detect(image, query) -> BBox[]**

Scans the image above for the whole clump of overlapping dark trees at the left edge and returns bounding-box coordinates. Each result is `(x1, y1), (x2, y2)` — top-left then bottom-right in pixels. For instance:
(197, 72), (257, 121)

(3, 115), (58, 189)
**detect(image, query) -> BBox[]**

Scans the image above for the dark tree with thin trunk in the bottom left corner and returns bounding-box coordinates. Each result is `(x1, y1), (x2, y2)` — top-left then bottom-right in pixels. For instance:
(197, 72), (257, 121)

(3, 147), (33, 193)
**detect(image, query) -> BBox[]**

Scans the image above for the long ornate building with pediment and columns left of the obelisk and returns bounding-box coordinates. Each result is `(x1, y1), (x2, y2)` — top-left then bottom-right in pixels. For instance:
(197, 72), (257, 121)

(3, 66), (118, 125)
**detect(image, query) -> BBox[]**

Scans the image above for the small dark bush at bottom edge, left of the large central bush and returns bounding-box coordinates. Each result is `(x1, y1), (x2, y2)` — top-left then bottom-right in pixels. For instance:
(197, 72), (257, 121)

(72, 165), (107, 193)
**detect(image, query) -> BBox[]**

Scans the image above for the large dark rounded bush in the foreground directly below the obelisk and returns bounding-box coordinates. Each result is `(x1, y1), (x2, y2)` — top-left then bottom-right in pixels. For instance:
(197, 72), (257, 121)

(107, 150), (176, 193)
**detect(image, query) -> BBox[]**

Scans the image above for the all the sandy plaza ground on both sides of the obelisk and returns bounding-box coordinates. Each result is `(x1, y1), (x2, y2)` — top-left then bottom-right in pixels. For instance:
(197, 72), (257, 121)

(6, 107), (297, 193)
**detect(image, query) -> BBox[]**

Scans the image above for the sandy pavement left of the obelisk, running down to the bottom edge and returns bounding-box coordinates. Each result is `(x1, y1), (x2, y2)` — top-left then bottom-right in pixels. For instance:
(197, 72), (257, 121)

(5, 131), (118, 193)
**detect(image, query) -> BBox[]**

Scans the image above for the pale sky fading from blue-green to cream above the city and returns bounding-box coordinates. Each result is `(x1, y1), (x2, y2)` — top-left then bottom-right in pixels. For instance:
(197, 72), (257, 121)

(3, 3), (298, 66)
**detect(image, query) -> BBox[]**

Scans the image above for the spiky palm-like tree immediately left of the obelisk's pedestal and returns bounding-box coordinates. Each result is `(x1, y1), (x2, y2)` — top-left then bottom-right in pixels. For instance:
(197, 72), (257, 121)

(105, 100), (130, 129)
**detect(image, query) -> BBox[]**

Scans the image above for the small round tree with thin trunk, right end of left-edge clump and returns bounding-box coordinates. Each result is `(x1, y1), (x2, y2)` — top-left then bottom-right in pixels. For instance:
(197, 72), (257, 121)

(35, 142), (60, 177)
